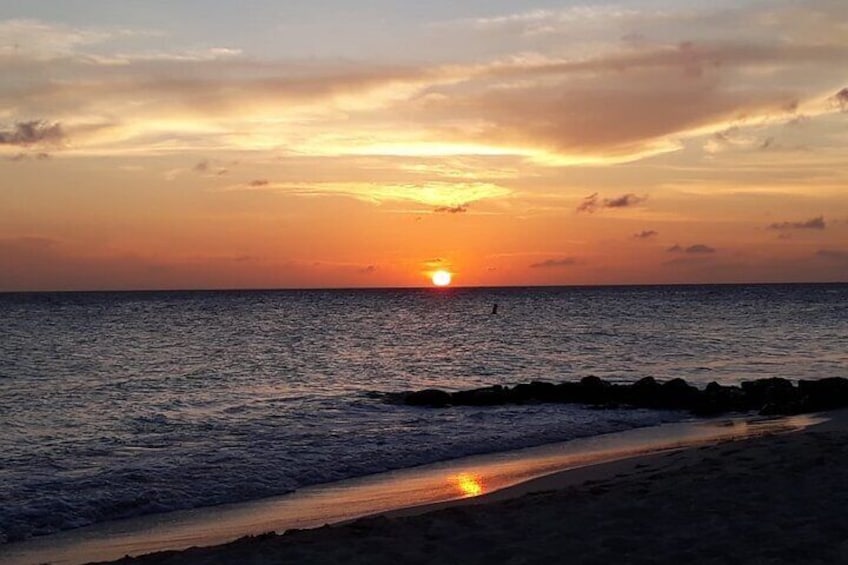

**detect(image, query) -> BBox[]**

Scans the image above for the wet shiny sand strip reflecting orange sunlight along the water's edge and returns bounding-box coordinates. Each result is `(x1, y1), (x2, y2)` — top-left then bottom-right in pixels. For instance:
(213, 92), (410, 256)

(0, 410), (815, 564)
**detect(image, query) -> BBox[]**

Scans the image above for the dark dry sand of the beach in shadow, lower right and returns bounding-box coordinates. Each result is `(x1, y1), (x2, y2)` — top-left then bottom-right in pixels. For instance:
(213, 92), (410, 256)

(106, 411), (848, 565)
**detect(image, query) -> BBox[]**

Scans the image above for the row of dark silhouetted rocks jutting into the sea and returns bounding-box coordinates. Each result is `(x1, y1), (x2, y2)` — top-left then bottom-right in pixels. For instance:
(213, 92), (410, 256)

(387, 376), (848, 416)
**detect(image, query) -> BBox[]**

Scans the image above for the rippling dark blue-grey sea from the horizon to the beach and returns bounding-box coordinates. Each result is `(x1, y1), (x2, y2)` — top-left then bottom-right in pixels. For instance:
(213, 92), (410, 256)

(0, 284), (848, 543)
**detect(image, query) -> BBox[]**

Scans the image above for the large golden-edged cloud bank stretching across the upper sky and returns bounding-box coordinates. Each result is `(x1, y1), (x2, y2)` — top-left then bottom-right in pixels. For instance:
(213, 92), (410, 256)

(0, 2), (848, 165)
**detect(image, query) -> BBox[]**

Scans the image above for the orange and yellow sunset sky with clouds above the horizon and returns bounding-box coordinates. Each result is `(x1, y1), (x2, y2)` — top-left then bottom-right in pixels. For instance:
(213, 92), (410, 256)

(0, 0), (848, 291)
